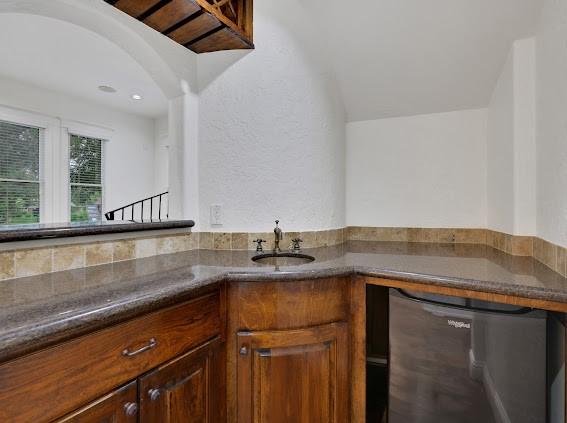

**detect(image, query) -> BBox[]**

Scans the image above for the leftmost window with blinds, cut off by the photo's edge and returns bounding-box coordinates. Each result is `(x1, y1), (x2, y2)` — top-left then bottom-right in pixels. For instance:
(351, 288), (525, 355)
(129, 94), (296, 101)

(0, 121), (43, 225)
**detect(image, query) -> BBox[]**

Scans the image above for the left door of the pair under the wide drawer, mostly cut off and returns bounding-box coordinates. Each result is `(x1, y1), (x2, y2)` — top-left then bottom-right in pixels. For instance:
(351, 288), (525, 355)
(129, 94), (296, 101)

(57, 382), (138, 423)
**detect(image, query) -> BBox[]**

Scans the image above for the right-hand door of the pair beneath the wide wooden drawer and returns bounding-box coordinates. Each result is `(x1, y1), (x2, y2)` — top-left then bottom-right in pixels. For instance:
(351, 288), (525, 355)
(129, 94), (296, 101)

(140, 339), (225, 423)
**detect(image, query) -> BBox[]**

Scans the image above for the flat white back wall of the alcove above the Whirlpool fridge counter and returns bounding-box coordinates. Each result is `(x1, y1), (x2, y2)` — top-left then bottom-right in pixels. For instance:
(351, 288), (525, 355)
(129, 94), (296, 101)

(346, 109), (486, 228)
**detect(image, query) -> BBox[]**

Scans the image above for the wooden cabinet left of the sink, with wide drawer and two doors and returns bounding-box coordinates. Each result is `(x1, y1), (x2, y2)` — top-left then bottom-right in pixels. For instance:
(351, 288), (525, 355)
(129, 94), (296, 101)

(0, 290), (225, 423)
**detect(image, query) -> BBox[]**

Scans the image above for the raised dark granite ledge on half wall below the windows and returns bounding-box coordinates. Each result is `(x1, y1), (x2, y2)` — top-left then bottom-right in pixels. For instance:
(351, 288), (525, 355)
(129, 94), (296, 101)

(0, 220), (195, 242)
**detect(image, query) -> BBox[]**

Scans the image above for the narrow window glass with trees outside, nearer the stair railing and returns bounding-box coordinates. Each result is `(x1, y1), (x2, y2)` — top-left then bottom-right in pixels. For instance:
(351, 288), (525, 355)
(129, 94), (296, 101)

(69, 134), (103, 222)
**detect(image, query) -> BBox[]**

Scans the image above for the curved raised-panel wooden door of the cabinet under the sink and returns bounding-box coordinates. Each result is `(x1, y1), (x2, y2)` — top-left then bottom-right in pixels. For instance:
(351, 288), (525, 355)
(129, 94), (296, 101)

(237, 323), (350, 423)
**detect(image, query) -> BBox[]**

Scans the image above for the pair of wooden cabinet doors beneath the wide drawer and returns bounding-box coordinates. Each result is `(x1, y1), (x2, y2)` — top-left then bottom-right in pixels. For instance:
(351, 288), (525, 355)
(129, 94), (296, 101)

(57, 338), (225, 423)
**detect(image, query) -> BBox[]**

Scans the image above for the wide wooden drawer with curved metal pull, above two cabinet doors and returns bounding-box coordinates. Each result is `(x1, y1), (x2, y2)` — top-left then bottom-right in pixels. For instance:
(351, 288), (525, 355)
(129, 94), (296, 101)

(0, 293), (221, 422)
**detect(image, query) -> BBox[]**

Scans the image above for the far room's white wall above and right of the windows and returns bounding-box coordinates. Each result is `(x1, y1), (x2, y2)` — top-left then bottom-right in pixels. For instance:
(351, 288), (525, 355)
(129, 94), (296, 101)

(0, 78), (155, 220)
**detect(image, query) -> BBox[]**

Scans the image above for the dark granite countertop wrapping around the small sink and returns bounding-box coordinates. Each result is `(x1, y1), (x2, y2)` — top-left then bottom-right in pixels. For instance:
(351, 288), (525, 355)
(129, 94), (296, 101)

(0, 241), (567, 361)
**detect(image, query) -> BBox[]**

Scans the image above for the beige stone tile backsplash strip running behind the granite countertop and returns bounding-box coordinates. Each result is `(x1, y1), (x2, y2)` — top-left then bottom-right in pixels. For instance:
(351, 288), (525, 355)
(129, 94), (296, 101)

(0, 226), (567, 280)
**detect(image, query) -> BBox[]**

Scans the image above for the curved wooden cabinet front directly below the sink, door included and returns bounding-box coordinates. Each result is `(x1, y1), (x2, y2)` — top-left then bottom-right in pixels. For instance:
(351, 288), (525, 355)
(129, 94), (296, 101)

(227, 278), (351, 423)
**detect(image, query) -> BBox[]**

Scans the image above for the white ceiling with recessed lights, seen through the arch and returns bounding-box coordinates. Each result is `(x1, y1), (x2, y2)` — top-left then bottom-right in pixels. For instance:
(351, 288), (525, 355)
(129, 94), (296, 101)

(0, 14), (167, 117)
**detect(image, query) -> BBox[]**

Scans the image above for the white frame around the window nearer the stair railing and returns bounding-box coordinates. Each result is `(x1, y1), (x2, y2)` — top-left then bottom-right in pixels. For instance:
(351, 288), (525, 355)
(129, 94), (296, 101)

(59, 120), (114, 222)
